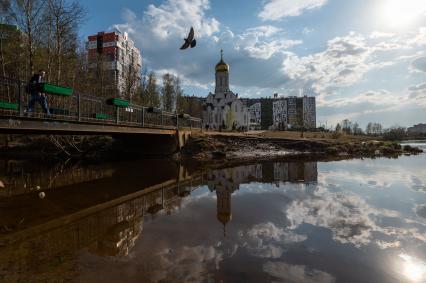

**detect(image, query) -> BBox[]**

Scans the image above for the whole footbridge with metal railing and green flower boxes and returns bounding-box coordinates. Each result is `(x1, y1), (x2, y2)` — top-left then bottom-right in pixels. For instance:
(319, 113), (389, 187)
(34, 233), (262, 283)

(0, 78), (201, 152)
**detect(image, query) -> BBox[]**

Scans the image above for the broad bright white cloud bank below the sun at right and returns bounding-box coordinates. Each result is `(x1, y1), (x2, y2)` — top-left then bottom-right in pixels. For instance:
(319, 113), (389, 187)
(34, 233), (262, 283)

(282, 29), (426, 95)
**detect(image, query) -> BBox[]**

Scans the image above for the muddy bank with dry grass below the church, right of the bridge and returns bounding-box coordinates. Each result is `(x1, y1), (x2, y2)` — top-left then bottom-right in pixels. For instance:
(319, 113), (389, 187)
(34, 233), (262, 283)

(181, 135), (422, 162)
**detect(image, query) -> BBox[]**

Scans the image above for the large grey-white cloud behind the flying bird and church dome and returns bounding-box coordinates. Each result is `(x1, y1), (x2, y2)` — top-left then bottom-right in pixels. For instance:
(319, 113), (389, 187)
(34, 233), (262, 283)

(111, 0), (301, 91)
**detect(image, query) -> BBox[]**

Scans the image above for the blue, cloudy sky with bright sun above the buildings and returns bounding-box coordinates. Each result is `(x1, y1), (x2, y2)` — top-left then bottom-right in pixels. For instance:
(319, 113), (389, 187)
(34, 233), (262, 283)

(78, 0), (426, 127)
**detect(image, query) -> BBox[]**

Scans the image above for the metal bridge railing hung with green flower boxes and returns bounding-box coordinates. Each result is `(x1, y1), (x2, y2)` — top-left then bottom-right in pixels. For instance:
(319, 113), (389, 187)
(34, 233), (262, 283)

(0, 77), (201, 129)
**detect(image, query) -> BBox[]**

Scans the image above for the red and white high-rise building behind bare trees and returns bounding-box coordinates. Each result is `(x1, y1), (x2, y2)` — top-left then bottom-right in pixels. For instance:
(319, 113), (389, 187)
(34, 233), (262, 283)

(87, 30), (142, 96)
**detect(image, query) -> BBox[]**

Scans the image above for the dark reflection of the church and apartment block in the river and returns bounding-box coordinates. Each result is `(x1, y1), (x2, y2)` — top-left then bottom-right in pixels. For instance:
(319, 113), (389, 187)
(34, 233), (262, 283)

(207, 162), (318, 237)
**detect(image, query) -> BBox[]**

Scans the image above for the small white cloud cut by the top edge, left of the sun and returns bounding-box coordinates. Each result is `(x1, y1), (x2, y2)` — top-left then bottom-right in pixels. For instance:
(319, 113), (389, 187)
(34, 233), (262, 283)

(258, 0), (327, 21)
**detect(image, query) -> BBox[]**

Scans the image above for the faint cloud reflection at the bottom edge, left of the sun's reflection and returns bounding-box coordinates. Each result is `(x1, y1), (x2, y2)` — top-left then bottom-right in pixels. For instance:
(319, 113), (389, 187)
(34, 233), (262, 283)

(263, 261), (336, 283)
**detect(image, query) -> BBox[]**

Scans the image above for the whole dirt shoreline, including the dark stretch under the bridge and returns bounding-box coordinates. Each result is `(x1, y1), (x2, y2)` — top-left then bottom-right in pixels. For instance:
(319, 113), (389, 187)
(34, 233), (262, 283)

(0, 133), (422, 164)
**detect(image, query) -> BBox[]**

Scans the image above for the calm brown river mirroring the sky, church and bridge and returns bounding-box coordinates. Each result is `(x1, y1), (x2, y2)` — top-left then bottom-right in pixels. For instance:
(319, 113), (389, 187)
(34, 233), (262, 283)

(0, 153), (426, 282)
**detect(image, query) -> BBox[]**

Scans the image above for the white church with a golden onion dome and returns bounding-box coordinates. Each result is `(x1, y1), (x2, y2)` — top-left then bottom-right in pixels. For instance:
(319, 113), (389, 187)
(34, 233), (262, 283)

(203, 50), (250, 131)
